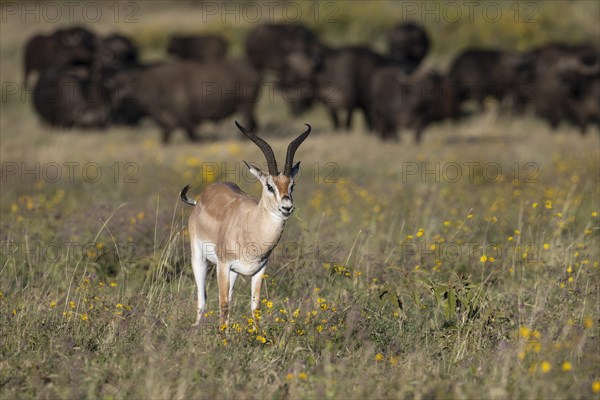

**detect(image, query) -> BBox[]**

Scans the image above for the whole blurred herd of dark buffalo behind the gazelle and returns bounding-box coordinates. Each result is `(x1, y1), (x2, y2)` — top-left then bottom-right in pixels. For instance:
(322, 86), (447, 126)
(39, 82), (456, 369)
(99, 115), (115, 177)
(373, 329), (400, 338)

(24, 22), (600, 143)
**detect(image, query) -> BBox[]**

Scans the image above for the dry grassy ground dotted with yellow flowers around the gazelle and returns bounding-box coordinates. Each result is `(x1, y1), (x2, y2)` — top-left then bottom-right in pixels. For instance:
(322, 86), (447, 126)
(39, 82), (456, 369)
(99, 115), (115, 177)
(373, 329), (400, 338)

(0, 2), (600, 399)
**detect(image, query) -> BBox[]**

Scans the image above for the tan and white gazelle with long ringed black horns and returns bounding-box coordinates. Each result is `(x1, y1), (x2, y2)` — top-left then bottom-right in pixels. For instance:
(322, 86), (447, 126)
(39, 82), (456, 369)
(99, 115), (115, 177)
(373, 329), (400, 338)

(180, 121), (311, 328)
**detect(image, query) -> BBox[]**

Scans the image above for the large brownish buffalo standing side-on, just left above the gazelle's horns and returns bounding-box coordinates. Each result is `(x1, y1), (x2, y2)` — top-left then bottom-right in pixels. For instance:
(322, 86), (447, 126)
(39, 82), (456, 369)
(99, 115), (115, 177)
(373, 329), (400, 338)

(114, 61), (260, 143)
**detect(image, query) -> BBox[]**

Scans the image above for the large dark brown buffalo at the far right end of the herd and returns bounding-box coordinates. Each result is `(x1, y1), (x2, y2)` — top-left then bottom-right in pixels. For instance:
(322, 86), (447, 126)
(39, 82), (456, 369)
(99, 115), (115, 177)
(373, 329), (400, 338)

(518, 43), (600, 129)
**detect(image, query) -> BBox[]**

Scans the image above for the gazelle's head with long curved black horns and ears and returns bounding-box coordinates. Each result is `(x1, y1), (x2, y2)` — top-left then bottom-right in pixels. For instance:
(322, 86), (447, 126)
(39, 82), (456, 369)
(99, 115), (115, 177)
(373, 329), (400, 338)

(235, 121), (311, 220)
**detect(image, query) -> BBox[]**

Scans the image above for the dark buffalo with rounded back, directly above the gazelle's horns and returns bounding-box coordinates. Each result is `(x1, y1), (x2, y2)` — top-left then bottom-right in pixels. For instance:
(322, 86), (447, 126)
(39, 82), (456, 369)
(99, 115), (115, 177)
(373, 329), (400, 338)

(246, 24), (320, 72)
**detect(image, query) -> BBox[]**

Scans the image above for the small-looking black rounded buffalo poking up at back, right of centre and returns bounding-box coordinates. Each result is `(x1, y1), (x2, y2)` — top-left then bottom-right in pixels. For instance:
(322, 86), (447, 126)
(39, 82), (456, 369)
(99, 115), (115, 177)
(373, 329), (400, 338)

(387, 22), (429, 74)
